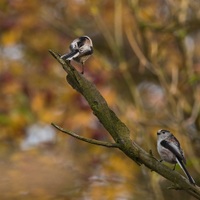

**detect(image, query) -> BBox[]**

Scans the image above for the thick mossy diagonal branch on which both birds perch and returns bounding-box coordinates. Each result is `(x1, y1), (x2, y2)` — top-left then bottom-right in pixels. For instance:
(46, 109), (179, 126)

(50, 50), (200, 199)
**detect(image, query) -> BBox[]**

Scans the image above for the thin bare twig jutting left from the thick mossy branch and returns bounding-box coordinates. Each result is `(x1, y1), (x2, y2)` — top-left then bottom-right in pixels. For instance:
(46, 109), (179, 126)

(51, 123), (120, 148)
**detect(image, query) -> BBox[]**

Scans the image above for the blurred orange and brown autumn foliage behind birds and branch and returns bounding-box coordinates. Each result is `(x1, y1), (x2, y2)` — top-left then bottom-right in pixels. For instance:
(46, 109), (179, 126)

(0, 0), (200, 200)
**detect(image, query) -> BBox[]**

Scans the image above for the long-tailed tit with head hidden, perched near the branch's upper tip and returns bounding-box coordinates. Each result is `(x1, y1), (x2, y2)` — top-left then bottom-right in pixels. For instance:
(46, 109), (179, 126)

(61, 36), (93, 74)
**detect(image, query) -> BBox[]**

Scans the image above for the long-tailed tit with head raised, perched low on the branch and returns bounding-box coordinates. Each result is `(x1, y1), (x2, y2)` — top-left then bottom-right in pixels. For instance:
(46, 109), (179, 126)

(157, 130), (195, 185)
